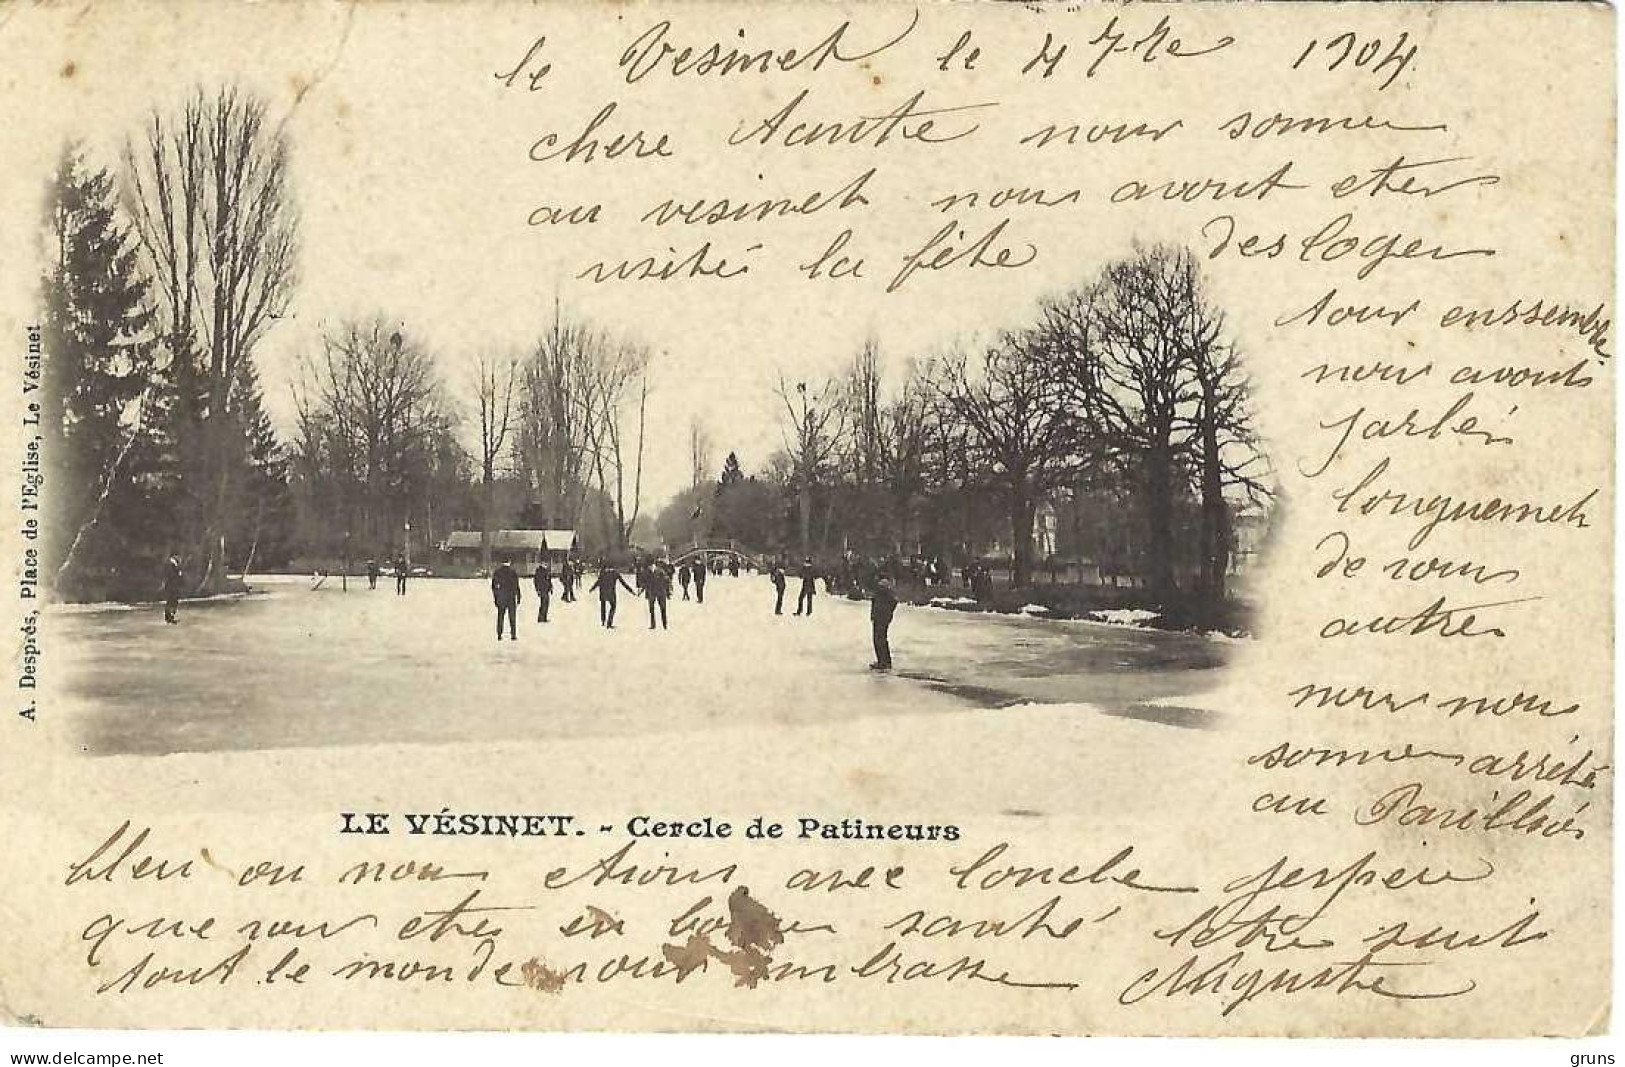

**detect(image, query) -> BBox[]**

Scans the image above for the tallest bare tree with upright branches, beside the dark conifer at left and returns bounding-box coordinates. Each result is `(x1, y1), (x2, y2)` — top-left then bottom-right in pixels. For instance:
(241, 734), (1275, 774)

(125, 88), (297, 590)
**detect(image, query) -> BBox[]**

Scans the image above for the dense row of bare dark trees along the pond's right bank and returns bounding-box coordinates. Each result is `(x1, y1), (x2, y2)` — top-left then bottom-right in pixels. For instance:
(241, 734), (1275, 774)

(658, 245), (1272, 599)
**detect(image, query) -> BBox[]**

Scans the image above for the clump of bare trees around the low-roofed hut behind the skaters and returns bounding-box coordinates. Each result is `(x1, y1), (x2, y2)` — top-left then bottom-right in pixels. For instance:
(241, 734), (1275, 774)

(293, 298), (652, 567)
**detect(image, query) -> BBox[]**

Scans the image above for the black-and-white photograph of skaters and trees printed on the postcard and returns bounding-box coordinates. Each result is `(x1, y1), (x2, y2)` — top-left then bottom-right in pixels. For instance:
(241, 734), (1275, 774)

(42, 84), (1274, 758)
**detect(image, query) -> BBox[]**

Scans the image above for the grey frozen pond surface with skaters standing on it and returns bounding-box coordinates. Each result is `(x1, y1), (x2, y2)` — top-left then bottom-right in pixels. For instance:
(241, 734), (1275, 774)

(49, 575), (1233, 755)
